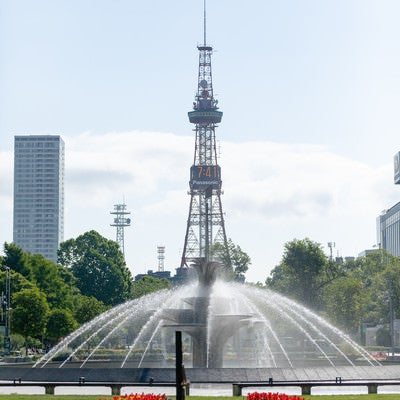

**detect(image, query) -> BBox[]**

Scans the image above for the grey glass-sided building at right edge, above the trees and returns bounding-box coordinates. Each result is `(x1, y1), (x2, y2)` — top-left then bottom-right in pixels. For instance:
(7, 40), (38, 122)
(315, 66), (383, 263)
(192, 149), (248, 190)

(376, 203), (400, 256)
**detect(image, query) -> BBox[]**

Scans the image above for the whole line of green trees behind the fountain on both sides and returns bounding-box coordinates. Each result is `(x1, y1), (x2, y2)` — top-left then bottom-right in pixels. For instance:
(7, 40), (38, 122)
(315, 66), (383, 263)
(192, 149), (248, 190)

(0, 231), (394, 354)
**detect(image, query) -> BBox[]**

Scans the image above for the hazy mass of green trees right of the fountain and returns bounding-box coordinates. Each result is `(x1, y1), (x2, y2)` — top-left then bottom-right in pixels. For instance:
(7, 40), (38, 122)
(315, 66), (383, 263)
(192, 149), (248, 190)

(265, 238), (400, 346)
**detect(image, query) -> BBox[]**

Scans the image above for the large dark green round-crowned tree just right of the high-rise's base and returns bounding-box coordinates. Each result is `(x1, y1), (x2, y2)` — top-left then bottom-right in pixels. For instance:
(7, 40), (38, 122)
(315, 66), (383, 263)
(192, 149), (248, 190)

(58, 231), (132, 306)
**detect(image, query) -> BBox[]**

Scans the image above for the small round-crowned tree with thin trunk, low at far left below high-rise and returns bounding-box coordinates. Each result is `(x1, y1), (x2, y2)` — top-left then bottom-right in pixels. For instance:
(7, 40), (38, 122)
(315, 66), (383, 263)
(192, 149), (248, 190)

(11, 288), (49, 351)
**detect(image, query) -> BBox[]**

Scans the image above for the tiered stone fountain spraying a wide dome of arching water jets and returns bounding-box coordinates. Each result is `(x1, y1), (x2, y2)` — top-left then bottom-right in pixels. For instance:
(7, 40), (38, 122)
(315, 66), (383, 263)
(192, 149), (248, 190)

(34, 260), (379, 368)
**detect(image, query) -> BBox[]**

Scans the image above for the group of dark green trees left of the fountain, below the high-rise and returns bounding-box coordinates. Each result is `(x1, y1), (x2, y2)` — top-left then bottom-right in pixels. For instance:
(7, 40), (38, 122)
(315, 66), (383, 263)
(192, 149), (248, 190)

(0, 231), (170, 349)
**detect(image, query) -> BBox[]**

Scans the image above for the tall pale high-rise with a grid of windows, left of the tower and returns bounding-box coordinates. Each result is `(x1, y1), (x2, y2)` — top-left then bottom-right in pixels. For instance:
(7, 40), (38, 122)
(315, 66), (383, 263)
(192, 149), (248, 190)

(13, 135), (64, 261)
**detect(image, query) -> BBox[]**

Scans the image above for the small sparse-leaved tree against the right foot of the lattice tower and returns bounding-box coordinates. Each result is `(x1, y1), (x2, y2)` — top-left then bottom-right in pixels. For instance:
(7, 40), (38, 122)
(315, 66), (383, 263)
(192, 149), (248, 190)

(211, 239), (251, 282)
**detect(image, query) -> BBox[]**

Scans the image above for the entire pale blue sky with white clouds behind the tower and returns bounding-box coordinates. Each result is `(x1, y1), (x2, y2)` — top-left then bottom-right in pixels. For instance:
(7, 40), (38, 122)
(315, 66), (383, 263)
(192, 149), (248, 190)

(0, 0), (400, 281)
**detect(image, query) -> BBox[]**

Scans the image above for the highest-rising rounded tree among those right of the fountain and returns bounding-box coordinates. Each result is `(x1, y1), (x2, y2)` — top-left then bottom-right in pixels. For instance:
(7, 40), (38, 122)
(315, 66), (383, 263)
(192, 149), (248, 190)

(266, 238), (342, 309)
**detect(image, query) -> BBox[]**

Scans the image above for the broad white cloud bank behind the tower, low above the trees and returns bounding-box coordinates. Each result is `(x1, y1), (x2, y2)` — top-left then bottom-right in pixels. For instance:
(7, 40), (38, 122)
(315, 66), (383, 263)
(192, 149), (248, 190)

(0, 131), (397, 281)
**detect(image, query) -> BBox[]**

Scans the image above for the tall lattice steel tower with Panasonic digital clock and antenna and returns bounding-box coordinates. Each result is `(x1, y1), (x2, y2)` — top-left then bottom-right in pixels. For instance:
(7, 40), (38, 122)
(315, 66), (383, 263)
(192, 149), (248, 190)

(181, 1), (226, 268)
